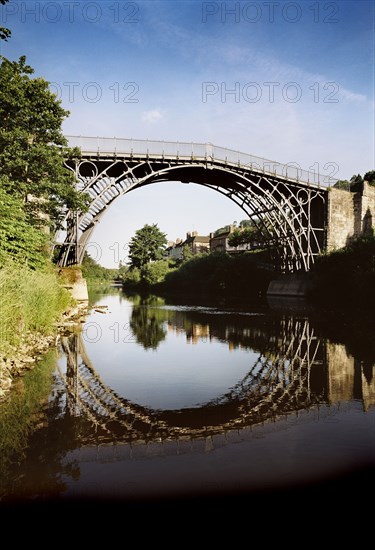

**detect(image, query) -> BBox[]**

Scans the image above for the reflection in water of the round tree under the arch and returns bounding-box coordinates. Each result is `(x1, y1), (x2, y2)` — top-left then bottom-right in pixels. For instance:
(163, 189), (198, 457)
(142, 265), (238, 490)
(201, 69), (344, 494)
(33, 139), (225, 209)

(129, 297), (167, 349)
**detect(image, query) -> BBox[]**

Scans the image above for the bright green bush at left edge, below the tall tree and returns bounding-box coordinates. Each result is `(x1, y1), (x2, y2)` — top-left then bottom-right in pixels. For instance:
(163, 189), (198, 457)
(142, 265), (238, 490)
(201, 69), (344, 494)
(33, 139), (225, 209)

(0, 177), (49, 269)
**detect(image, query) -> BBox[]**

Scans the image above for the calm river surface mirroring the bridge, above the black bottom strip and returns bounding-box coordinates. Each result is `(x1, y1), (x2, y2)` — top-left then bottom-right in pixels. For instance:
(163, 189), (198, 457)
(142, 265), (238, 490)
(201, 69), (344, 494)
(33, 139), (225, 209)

(0, 290), (375, 502)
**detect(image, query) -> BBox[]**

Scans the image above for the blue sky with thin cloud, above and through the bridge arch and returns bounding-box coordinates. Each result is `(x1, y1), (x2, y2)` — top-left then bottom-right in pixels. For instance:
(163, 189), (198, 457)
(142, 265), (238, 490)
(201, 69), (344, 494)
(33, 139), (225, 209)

(0, 0), (375, 267)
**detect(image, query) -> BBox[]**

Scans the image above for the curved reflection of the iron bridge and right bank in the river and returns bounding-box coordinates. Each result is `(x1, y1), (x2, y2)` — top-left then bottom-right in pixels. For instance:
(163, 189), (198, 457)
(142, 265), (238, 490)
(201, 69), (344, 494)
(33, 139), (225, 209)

(55, 303), (375, 444)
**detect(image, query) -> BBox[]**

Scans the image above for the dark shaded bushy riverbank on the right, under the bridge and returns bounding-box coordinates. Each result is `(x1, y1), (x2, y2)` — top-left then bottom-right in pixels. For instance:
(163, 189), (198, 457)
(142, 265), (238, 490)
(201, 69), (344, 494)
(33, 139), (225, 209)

(123, 235), (375, 311)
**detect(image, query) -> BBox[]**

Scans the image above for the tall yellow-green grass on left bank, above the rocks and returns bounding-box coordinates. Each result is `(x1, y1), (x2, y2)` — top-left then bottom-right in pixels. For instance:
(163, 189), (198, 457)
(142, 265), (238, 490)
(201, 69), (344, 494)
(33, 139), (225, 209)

(0, 265), (71, 352)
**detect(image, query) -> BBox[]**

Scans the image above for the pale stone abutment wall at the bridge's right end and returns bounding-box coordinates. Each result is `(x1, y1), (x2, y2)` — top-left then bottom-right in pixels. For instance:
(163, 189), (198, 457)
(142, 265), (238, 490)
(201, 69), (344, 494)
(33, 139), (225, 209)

(327, 182), (375, 252)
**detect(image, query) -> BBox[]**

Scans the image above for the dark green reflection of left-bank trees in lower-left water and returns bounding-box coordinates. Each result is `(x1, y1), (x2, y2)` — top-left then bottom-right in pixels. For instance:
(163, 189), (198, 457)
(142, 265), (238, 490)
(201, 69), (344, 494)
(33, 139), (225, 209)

(0, 354), (80, 502)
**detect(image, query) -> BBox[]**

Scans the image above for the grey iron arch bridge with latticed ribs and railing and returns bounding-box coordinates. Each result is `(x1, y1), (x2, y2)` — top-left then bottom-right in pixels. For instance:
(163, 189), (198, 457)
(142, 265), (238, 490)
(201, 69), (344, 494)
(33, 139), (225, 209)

(55, 136), (335, 272)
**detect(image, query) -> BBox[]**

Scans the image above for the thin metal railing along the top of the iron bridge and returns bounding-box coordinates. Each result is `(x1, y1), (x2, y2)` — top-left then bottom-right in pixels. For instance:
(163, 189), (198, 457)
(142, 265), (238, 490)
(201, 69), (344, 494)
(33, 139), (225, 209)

(66, 136), (337, 187)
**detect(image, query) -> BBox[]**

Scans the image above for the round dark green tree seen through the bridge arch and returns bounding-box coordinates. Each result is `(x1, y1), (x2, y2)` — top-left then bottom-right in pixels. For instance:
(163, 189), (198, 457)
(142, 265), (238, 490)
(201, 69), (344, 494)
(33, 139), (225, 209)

(129, 223), (167, 270)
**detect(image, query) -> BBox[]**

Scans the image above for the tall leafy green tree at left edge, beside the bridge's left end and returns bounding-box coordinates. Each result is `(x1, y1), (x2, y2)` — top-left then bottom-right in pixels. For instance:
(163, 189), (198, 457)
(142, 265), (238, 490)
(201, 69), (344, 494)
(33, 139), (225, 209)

(0, 56), (87, 234)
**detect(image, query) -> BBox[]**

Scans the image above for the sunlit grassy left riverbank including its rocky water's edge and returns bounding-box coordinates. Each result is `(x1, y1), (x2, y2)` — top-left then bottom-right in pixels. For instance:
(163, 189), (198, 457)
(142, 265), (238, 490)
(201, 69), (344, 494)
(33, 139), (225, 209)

(0, 267), (88, 401)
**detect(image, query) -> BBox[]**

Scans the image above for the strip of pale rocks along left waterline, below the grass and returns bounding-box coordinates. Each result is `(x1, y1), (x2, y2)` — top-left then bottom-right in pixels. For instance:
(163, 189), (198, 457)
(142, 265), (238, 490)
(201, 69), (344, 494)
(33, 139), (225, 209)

(0, 301), (90, 402)
